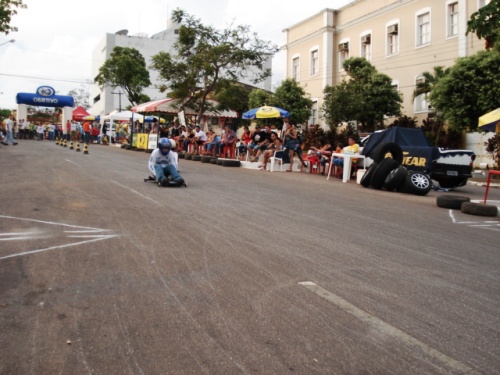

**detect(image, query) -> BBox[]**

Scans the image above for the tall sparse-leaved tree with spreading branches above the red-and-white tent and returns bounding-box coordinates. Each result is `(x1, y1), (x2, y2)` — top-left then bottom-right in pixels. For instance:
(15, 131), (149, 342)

(151, 9), (278, 122)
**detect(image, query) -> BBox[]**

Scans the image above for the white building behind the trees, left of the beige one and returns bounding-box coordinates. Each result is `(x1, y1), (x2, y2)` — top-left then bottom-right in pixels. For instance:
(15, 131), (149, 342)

(89, 23), (272, 116)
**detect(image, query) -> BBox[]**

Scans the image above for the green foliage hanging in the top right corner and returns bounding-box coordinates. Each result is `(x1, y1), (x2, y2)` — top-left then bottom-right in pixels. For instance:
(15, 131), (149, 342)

(465, 0), (500, 50)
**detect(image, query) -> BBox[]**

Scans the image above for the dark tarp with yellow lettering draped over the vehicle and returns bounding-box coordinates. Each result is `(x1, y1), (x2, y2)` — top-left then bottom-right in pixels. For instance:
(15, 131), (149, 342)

(362, 126), (439, 171)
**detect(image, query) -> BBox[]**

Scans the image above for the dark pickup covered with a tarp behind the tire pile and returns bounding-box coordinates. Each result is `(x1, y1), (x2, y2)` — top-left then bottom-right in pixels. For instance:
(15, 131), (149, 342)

(361, 127), (476, 188)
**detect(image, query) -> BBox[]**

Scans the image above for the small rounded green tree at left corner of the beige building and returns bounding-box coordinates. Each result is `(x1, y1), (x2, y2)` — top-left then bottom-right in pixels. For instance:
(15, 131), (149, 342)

(272, 78), (312, 124)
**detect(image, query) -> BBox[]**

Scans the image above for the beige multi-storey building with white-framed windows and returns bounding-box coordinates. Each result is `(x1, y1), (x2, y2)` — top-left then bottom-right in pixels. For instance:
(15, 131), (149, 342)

(284, 0), (489, 126)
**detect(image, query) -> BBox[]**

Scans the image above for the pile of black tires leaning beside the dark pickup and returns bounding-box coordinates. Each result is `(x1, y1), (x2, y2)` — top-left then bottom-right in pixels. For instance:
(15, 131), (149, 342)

(360, 143), (432, 195)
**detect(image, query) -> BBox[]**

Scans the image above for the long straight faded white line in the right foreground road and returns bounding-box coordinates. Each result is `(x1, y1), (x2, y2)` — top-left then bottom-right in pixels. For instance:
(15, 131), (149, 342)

(299, 281), (479, 375)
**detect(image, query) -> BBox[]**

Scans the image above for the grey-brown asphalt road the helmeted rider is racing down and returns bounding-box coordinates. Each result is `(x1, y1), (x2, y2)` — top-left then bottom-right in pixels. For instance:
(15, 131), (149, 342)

(0, 140), (500, 375)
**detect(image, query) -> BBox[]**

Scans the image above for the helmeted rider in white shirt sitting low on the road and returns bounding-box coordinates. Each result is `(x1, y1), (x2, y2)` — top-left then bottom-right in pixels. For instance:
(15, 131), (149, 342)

(148, 138), (186, 186)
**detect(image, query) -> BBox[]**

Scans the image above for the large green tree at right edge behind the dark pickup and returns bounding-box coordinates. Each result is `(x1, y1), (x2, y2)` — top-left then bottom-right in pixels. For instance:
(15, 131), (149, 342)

(430, 50), (500, 131)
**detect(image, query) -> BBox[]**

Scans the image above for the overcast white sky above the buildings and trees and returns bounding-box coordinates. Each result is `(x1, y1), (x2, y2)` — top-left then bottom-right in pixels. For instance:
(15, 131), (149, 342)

(0, 0), (353, 109)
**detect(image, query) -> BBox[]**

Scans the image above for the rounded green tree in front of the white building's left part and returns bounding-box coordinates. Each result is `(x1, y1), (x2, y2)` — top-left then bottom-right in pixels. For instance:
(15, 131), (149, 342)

(95, 47), (151, 105)
